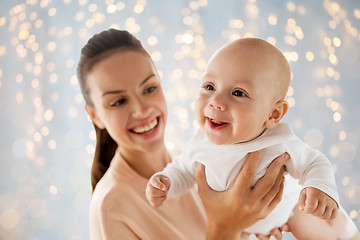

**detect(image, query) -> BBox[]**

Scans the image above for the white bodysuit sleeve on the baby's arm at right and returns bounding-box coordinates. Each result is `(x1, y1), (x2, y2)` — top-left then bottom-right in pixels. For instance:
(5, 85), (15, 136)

(285, 138), (339, 205)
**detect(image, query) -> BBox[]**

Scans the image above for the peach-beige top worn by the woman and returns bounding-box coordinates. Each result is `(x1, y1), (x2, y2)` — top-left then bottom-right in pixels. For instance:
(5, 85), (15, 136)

(90, 151), (205, 240)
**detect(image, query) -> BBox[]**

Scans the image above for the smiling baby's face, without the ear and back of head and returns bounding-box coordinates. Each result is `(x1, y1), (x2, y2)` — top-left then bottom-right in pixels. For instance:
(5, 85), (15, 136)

(195, 40), (278, 144)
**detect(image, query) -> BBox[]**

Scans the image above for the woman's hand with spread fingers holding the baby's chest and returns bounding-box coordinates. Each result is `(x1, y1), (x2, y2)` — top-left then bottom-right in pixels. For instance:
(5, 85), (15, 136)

(196, 151), (288, 239)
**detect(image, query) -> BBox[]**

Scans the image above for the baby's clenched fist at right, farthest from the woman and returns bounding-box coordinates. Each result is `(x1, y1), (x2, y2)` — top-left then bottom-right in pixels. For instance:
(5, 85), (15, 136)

(299, 187), (339, 219)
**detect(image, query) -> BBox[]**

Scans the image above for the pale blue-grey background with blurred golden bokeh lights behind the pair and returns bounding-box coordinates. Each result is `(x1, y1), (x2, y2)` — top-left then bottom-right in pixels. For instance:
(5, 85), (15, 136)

(0, 0), (360, 240)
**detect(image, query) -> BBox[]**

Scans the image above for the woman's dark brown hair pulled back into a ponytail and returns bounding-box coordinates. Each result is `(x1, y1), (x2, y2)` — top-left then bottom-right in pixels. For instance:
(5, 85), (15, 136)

(77, 29), (148, 191)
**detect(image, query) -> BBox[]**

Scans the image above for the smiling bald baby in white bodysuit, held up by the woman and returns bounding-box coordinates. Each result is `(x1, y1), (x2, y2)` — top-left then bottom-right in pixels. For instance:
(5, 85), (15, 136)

(146, 38), (358, 240)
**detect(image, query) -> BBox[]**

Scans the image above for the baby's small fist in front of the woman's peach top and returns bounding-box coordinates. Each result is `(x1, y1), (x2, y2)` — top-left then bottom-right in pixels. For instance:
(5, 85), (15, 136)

(146, 175), (170, 207)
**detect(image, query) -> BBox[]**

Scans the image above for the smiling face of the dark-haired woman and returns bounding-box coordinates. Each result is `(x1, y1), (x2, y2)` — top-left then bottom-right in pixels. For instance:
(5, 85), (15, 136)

(86, 51), (167, 154)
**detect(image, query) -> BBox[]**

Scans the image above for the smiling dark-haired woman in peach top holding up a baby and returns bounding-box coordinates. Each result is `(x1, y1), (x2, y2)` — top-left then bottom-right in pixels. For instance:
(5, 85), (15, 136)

(78, 29), (285, 239)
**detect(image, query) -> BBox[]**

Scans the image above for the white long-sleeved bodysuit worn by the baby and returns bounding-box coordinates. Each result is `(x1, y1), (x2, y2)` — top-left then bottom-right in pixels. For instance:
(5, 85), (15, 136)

(157, 123), (339, 234)
